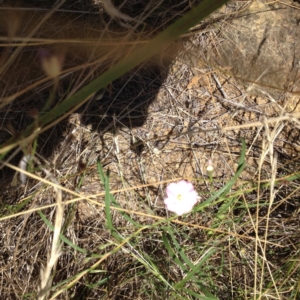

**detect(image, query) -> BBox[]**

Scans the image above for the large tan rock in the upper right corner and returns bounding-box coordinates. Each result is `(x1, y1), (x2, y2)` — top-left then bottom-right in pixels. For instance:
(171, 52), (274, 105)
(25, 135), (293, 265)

(208, 0), (300, 98)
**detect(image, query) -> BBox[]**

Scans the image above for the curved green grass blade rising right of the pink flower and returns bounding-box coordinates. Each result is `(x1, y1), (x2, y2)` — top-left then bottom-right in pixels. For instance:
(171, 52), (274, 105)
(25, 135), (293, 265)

(194, 139), (246, 211)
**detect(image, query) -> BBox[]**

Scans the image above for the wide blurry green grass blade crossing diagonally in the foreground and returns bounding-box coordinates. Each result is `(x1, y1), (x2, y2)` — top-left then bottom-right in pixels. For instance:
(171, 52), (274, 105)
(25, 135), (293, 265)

(0, 0), (229, 153)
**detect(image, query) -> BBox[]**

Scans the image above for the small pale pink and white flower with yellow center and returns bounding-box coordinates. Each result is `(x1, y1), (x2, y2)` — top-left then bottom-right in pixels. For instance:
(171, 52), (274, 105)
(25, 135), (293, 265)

(164, 180), (199, 216)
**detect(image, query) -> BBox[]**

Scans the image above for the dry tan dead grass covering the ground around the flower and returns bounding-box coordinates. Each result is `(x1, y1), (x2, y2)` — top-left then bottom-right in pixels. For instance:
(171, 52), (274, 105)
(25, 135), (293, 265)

(0, 1), (300, 299)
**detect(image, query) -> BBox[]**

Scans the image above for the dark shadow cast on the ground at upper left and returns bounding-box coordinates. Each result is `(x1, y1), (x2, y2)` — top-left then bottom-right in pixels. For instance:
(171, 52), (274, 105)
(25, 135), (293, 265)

(0, 1), (197, 187)
